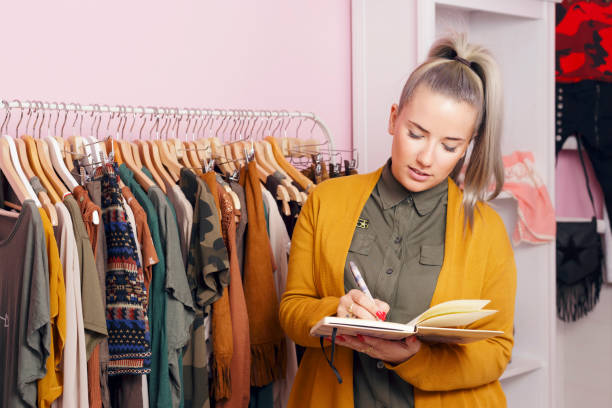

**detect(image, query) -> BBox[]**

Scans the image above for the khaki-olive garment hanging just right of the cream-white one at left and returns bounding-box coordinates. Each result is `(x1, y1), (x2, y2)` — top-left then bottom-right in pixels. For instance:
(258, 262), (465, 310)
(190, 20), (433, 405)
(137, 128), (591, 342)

(64, 194), (108, 359)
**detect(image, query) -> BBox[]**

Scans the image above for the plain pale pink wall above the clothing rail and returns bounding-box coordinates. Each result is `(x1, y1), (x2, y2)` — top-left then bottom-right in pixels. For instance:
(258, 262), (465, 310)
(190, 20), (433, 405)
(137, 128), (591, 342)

(0, 0), (352, 148)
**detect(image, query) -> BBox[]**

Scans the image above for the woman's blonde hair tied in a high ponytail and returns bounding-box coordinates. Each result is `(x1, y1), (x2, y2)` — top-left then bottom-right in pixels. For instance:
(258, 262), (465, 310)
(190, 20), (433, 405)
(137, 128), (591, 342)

(399, 34), (504, 225)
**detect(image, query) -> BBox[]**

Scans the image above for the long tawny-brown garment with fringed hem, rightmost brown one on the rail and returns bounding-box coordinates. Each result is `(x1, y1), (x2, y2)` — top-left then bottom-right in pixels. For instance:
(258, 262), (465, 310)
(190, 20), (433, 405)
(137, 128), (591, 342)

(240, 162), (286, 386)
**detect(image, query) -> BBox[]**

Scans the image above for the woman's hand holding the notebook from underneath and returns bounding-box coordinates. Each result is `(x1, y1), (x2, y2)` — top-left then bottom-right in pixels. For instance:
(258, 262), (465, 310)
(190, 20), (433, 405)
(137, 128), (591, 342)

(336, 335), (421, 365)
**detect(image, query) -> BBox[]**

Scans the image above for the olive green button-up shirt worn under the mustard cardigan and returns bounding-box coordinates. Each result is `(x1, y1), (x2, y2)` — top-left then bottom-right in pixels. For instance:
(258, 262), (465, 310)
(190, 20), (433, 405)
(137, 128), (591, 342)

(344, 160), (448, 408)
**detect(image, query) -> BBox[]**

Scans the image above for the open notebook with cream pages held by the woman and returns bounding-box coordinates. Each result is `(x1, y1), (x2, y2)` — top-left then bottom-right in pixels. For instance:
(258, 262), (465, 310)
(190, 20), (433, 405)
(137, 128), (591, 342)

(310, 299), (503, 344)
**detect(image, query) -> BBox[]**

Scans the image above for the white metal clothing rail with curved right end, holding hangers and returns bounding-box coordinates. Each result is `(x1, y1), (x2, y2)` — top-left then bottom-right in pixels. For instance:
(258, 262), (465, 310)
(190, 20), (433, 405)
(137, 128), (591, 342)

(0, 99), (334, 154)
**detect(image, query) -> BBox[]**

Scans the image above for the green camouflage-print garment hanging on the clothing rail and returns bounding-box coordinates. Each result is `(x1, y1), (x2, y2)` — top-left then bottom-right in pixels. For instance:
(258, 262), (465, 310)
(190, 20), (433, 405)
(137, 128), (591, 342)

(179, 169), (229, 408)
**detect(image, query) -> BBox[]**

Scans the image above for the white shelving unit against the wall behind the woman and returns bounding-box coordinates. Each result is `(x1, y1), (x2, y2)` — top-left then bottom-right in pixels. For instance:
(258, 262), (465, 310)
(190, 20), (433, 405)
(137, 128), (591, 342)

(352, 0), (558, 408)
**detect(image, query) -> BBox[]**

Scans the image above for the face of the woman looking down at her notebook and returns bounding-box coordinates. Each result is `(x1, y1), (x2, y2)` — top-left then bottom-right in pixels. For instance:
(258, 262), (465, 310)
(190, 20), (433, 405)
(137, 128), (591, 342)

(389, 85), (478, 192)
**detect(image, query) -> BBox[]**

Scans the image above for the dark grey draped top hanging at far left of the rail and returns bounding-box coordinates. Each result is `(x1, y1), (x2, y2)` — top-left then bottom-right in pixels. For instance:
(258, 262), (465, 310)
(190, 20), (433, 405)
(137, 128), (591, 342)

(0, 201), (52, 408)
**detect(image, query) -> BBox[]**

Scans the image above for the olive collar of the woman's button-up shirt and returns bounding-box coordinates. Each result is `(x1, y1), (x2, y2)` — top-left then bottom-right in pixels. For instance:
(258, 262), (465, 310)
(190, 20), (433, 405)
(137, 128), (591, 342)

(378, 159), (448, 215)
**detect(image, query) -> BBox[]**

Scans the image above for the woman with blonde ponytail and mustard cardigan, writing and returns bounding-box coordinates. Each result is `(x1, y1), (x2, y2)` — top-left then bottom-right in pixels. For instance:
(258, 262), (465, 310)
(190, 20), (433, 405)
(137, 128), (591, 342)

(280, 36), (516, 408)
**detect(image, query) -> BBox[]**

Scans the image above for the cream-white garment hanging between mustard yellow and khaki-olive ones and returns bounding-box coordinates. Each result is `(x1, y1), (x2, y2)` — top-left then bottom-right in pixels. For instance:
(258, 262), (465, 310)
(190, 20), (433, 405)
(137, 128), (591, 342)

(55, 203), (89, 408)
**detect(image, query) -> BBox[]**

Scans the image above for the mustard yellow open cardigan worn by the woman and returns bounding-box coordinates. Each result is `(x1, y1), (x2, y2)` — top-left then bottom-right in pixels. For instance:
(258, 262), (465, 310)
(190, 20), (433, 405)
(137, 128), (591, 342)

(280, 169), (516, 408)
